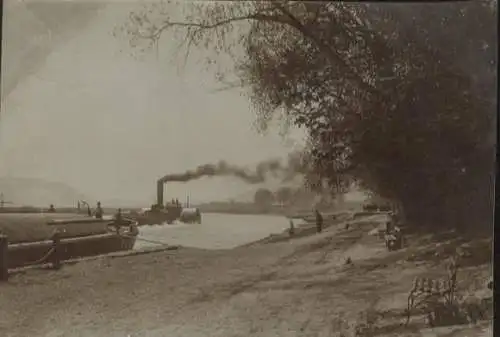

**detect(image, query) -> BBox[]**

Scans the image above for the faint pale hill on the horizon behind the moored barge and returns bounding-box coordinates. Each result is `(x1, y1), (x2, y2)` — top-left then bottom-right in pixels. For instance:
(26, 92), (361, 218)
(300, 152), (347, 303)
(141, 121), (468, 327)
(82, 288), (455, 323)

(0, 178), (88, 207)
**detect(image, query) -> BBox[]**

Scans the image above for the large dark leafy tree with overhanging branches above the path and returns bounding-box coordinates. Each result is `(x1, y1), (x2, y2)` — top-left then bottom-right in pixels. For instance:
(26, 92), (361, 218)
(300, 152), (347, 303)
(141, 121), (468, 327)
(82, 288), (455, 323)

(117, 1), (497, 228)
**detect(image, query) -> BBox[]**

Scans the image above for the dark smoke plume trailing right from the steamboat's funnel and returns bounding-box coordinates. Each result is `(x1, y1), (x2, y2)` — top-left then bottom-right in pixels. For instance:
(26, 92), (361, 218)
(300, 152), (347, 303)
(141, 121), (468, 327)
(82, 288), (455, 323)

(159, 153), (306, 184)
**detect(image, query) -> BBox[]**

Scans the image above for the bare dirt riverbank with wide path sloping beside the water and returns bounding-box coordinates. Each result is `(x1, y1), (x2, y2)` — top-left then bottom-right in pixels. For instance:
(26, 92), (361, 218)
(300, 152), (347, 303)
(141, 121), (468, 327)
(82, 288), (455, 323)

(0, 217), (492, 337)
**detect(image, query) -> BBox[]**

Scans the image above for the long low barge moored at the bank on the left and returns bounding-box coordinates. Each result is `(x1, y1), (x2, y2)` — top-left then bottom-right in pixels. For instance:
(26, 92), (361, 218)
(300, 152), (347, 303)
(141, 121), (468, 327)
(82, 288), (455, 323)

(0, 213), (138, 268)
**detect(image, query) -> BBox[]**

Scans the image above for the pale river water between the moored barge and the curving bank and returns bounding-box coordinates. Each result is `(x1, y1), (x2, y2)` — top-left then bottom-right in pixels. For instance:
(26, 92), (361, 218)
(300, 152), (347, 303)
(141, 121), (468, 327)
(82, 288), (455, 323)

(134, 213), (298, 249)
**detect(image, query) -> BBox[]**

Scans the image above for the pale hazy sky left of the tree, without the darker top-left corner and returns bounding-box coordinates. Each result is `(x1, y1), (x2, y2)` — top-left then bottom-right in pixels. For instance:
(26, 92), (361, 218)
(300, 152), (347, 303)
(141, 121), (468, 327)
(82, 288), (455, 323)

(0, 2), (306, 204)
